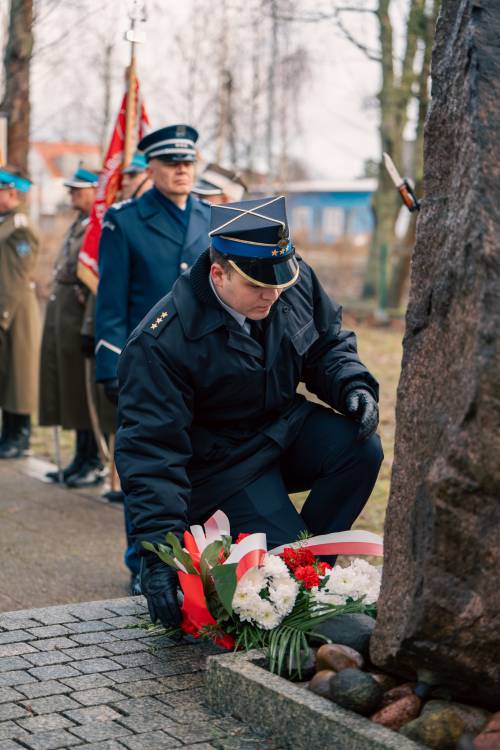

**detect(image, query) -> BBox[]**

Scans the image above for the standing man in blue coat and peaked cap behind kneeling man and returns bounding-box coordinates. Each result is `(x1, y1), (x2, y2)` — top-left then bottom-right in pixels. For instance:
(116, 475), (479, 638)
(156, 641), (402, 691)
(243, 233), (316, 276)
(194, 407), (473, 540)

(95, 125), (210, 593)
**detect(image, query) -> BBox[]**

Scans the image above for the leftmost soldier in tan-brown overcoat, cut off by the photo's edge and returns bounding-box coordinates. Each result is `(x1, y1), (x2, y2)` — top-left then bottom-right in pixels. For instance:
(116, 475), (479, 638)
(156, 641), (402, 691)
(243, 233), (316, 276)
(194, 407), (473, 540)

(0, 166), (40, 458)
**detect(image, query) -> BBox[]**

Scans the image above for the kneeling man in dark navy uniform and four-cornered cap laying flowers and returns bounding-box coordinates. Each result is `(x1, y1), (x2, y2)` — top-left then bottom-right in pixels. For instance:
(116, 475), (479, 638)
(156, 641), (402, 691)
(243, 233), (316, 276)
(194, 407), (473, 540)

(116, 198), (382, 625)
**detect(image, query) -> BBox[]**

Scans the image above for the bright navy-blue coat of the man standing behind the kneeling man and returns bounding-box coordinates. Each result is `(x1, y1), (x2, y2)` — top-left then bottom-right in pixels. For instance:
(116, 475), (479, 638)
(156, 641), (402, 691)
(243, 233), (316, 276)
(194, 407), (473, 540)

(95, 190), (210, 381)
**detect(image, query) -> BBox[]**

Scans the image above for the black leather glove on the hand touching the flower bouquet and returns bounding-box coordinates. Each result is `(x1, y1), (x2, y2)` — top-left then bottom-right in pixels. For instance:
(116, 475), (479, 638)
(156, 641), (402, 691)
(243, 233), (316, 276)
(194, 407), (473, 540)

(141, 557), (182, 628)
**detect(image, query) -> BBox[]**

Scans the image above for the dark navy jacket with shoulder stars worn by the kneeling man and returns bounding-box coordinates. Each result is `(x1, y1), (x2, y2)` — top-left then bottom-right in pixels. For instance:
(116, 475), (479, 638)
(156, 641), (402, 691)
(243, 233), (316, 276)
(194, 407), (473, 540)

(116, 252), (378, 542)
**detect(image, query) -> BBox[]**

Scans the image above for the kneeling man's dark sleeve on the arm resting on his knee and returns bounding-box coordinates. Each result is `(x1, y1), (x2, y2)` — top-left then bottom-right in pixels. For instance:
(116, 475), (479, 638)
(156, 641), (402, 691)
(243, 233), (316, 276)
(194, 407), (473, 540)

(303, 269), (378, 411)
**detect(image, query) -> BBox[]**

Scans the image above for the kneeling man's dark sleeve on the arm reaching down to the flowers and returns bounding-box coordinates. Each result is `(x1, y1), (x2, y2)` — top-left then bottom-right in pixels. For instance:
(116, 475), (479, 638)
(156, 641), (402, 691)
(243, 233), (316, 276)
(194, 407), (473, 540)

(116, 333), (193, 542)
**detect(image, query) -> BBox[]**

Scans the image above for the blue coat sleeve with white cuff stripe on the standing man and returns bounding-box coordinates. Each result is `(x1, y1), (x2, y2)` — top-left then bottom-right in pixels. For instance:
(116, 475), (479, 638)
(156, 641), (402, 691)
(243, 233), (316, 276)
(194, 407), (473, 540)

(95, 211), (130, 381)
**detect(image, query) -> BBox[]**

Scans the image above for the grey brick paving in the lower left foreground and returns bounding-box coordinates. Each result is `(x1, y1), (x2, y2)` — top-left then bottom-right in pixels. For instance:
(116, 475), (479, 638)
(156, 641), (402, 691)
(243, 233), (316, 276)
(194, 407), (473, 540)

(0, 598), (280, 750)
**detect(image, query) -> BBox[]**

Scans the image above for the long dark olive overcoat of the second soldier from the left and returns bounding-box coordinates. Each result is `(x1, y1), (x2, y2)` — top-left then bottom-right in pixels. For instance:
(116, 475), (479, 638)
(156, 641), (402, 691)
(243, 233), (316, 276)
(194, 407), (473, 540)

(40, 213), (92, 430)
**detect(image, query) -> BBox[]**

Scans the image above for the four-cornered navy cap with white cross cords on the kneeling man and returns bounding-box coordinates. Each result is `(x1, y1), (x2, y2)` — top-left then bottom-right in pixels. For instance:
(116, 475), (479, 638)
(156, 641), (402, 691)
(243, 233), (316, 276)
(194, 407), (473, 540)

(209, 196), (299, 289)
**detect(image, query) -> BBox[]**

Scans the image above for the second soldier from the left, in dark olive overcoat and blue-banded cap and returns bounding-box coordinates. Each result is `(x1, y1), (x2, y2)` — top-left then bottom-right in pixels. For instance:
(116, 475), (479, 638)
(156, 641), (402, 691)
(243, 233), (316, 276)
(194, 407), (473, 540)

(40, 167), (103, 487)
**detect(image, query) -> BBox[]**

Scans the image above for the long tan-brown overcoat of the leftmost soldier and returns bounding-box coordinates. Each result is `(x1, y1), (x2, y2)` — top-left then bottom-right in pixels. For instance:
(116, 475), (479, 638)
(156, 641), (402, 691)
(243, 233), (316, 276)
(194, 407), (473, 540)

(0, 211), (40, 414)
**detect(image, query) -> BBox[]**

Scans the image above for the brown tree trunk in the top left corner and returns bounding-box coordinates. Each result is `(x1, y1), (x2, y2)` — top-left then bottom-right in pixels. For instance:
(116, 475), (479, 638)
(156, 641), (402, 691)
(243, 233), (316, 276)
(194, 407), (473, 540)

(1, 0), (33, 171)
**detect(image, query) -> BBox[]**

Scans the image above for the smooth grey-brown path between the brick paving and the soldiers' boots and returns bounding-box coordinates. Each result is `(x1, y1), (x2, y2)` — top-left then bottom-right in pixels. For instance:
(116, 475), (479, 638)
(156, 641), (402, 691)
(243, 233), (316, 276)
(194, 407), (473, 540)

(0, 458), (129, 612)
